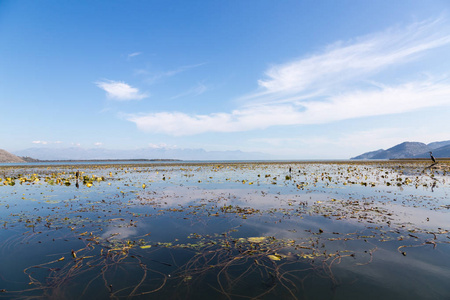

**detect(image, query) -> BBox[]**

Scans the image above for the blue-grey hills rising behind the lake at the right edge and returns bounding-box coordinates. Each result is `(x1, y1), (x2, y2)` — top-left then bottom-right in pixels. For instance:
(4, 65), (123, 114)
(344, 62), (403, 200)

(351, 141), (450, 159)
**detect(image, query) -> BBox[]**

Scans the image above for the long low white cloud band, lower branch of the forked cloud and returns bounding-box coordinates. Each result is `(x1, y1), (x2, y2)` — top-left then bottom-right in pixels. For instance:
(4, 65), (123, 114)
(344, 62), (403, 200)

(126, 81), (450, 136)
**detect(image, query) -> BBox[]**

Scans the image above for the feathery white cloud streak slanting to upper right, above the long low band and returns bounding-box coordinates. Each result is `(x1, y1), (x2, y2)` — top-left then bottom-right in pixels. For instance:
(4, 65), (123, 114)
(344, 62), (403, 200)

(249, 20), (450, 102)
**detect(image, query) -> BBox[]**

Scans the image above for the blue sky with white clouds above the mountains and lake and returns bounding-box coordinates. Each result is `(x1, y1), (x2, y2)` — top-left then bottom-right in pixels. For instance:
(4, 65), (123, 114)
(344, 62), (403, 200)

(0, 0), (450, 159)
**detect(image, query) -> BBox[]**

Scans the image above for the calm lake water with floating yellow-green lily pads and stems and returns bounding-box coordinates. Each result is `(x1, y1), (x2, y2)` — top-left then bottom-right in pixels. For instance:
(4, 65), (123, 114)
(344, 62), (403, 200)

(0, 161), (450, 299)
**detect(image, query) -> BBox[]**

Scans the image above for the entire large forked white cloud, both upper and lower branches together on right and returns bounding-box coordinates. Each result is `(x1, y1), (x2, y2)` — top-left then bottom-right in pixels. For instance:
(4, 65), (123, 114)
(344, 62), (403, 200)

(126, 20), (450, 136)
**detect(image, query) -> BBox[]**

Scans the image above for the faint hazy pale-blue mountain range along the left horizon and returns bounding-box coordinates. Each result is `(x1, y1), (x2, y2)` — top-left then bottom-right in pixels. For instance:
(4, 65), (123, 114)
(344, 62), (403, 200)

(15, 147), (270, 160)
